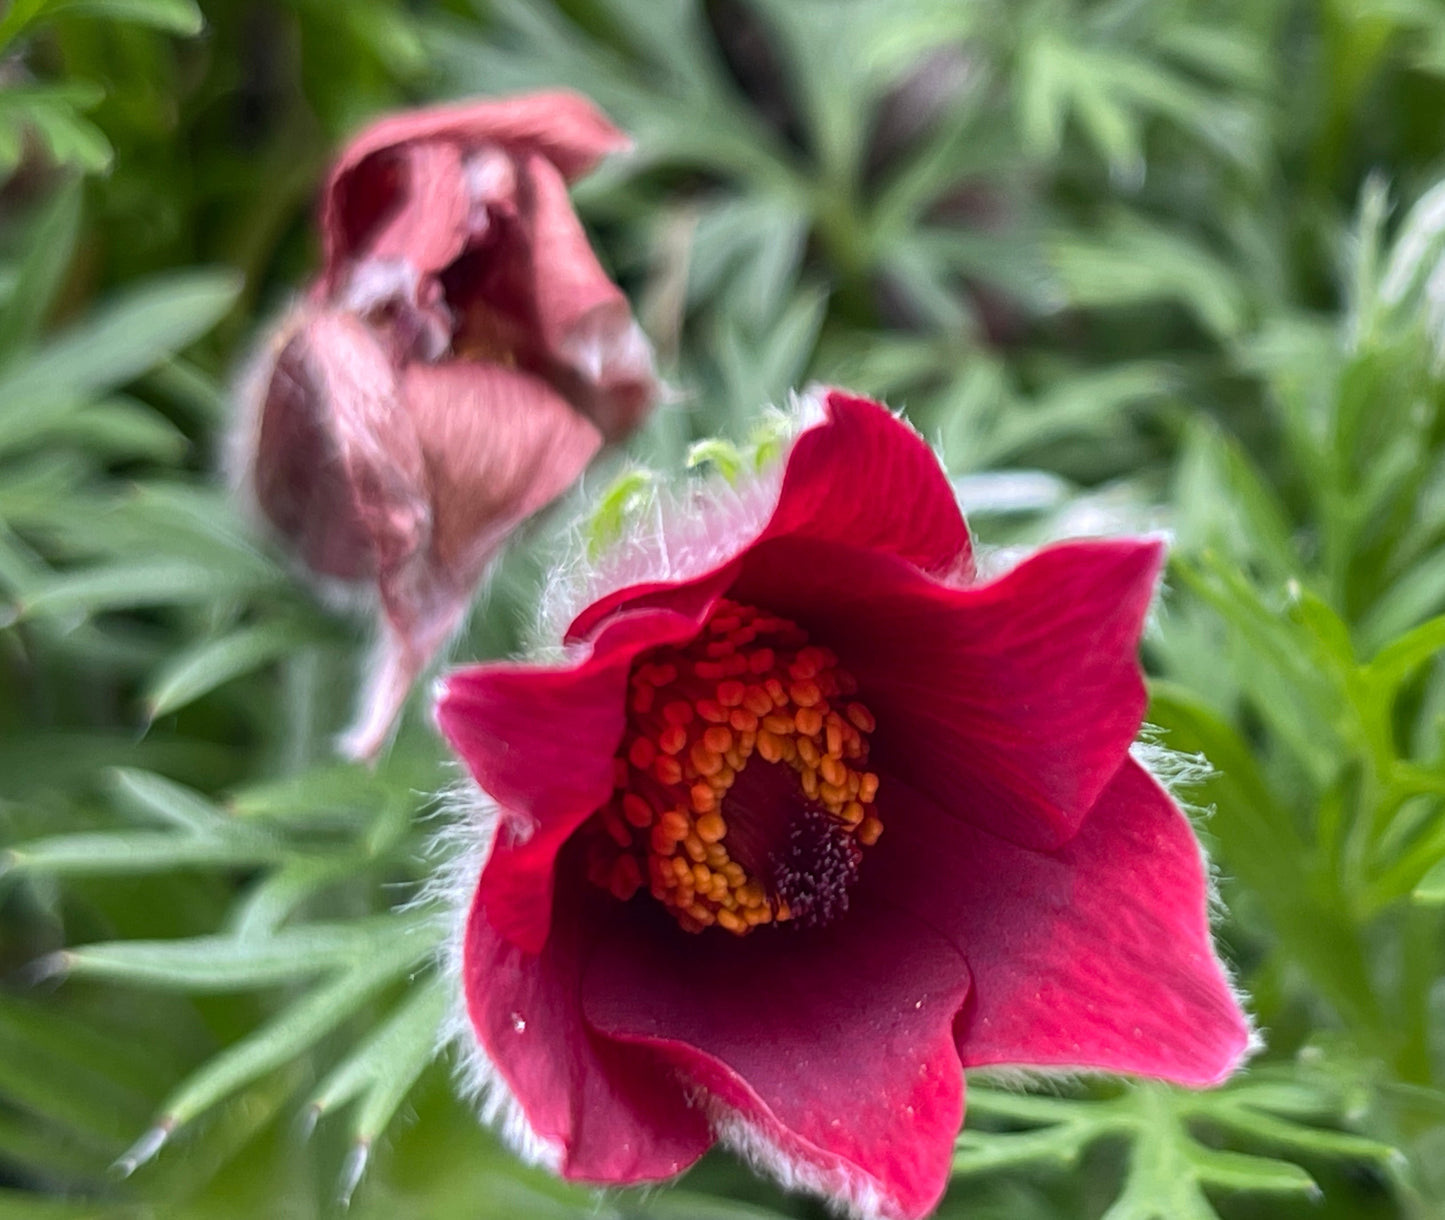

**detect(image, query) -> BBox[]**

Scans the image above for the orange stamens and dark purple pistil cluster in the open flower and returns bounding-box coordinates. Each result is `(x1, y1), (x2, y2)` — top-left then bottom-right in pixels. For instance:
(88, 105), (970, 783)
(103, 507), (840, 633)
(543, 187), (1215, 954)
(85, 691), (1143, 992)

(587, 600), (883, 935)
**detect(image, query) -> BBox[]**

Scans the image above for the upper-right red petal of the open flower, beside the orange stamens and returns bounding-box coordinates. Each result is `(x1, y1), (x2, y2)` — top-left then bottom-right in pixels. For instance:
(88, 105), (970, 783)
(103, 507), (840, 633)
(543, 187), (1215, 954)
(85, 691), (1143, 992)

(730, 539), (1163, 847)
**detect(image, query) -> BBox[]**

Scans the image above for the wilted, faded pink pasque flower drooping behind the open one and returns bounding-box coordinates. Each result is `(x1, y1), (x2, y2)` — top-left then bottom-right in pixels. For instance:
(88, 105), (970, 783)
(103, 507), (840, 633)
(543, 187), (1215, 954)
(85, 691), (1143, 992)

(241, 94), (657, 755)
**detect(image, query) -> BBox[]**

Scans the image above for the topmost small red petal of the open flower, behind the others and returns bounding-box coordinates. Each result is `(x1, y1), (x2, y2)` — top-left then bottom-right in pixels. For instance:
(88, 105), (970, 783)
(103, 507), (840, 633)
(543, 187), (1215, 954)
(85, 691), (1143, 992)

(759, 390), (972, 580)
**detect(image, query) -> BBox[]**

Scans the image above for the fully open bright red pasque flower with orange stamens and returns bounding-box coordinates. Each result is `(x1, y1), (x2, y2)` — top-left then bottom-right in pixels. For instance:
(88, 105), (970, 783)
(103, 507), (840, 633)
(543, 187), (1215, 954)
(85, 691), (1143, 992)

(438, 392), (1250, 1217)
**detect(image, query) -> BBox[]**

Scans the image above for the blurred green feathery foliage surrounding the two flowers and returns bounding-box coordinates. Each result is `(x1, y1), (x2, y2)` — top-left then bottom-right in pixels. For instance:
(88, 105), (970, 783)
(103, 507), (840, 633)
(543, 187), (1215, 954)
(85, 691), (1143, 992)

(0, 0), (1445, 1220)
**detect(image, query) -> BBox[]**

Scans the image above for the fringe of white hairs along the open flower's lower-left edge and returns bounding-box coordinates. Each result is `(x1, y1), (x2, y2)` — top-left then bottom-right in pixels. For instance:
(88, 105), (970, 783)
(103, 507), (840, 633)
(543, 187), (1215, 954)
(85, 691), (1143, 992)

(418, 781), (562, 1174)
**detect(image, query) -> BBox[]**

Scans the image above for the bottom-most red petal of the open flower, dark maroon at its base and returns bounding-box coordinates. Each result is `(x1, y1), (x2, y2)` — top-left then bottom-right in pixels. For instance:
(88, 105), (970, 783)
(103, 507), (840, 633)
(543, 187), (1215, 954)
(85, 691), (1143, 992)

(582, 905), (968, 1217)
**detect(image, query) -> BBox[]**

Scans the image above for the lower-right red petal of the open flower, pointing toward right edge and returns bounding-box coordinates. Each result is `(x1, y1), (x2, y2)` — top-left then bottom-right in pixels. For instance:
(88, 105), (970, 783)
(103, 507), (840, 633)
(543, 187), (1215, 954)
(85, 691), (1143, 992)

(863, 759), (1250, 1086)
